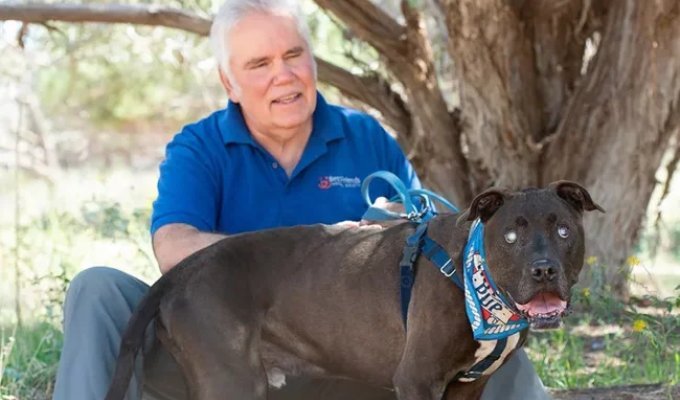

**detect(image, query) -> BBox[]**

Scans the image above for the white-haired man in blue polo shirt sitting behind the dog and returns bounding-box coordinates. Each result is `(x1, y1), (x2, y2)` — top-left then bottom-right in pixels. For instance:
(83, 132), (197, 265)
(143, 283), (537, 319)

(54, 0), (545, 400)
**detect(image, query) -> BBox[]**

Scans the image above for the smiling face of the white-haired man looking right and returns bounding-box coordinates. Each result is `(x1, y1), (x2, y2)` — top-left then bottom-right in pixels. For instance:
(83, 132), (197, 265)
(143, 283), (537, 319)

(222, 13), (316, 139)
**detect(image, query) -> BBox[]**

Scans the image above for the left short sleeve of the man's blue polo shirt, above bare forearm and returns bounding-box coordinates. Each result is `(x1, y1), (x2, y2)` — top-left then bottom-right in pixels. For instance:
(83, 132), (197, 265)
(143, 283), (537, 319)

(151, 127), (221, 235)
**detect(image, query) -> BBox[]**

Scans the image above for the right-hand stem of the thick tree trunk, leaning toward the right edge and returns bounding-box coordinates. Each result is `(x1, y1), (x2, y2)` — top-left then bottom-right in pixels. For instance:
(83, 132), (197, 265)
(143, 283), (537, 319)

(543, 0), (680, 297)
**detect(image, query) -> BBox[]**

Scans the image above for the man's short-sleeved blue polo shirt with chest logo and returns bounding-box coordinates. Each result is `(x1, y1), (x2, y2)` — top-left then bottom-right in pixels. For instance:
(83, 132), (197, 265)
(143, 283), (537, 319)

(151, 94), (420, 234)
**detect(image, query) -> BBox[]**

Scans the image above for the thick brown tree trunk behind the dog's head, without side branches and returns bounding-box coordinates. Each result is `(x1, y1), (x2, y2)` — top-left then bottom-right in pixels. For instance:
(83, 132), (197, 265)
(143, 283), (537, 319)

(430, 0), (680, 297)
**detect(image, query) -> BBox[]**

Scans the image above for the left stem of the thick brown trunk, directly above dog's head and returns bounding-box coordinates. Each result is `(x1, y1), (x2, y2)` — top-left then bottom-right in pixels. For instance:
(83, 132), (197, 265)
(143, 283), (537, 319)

(443, 0), (541, 187)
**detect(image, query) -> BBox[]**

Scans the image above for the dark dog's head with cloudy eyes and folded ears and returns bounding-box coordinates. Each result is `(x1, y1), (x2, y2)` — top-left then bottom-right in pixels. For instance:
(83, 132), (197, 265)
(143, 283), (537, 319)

(461, 181), (604, 329)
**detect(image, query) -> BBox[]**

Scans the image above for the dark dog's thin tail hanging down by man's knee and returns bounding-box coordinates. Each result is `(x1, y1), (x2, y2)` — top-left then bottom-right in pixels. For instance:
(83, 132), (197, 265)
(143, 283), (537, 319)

(105, 278), (167, 400)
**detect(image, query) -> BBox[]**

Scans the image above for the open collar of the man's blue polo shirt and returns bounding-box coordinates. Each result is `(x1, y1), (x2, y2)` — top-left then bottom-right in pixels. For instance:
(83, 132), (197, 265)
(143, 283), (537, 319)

(219, 91), (345, 146)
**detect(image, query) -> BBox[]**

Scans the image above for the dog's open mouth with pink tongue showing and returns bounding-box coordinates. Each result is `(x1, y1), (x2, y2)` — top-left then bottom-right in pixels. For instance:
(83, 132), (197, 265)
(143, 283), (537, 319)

(516, 292), (569, 331)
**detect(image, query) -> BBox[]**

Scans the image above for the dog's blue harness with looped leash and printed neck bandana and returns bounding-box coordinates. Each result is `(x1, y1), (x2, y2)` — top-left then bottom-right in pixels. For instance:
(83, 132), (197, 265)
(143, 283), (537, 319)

(361, 171), (529, 382)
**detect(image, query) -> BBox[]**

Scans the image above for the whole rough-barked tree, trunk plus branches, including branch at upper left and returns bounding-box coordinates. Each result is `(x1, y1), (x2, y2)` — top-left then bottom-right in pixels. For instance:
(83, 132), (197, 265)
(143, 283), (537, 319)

(0, 0), (680, 297)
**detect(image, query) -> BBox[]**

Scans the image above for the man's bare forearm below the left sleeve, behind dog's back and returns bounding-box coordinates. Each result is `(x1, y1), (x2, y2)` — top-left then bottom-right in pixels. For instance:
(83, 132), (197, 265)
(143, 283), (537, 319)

(153, 224), (226, 274)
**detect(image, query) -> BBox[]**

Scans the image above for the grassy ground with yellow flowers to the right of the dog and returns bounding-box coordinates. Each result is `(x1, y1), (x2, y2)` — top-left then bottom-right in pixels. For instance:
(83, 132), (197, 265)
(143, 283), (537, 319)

(527, 295), (680, 389)
